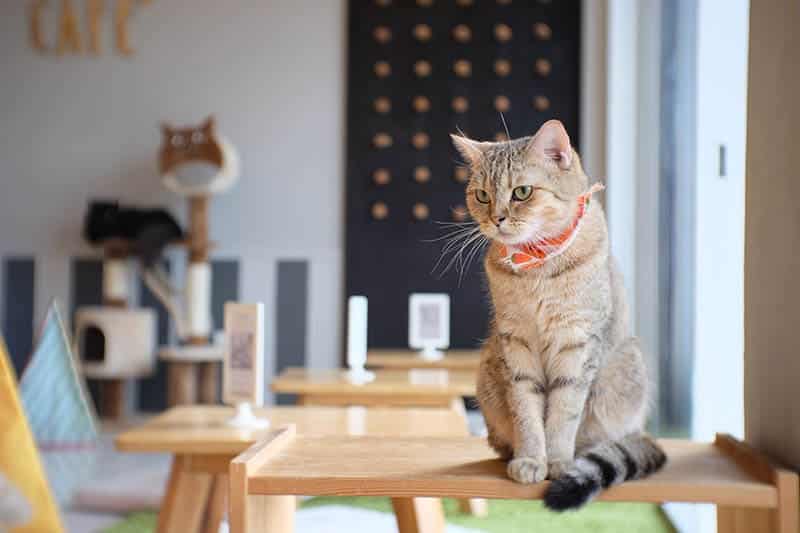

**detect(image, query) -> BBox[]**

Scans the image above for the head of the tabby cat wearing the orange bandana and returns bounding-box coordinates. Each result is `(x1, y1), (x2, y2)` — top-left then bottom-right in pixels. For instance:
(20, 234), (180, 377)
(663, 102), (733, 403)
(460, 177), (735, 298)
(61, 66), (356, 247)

(452, 120), (588, 244)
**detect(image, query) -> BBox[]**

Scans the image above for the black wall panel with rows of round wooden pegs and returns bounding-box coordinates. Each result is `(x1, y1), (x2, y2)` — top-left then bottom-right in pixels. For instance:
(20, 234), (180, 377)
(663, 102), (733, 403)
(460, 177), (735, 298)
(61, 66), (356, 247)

(346, 0), (580, 347)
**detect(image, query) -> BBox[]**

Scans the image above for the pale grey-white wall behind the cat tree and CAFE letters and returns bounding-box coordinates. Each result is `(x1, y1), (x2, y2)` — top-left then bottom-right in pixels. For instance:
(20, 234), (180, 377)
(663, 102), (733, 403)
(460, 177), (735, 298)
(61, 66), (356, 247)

(0, 0), (345, 382)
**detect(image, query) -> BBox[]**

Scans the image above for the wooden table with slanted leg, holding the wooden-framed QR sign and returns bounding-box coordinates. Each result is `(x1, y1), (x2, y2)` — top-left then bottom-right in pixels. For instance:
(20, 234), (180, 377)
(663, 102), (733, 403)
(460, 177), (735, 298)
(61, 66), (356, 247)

(115, 406), (482, 533)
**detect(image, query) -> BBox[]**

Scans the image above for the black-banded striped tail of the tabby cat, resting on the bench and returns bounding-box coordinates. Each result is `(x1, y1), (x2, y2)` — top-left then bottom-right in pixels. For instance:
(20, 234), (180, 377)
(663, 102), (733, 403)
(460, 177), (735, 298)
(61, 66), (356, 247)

(544, 433), (667, 511)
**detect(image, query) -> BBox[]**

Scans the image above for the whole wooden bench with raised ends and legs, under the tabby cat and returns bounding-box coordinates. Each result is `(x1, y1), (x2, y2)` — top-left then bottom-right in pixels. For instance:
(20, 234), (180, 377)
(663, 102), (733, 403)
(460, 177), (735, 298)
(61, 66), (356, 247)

(230, 426), (800, 533)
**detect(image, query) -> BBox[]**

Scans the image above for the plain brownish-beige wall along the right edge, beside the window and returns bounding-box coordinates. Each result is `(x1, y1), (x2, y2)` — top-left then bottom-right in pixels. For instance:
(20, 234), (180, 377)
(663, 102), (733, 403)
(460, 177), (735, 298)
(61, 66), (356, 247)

(745, 0), (800, 468)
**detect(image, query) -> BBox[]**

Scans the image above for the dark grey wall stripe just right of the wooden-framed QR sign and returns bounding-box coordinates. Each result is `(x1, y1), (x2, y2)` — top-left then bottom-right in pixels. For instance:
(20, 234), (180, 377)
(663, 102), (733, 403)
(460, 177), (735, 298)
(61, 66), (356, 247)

(275, 261), (308, 405)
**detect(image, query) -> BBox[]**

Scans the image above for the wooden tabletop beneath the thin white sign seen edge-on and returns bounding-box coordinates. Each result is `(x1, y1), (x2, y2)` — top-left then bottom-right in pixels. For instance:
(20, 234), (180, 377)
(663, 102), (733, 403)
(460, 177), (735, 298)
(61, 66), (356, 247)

(272, 368), (476, 398)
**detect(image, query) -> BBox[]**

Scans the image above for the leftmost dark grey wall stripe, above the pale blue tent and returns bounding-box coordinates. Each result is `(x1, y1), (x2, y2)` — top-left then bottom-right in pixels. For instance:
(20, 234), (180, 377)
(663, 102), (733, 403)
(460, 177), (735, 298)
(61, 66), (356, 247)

(2, 257), (36, 376)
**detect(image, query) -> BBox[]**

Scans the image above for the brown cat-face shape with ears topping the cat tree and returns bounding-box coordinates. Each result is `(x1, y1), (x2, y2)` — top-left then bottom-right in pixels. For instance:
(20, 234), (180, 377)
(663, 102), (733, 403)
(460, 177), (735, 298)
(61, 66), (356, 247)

(159, 117), (223, 174)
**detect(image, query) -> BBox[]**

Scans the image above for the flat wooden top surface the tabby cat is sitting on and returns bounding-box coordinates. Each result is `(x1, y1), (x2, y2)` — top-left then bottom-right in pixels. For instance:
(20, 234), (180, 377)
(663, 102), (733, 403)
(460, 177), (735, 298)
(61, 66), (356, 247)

(244, 429), (777, 507)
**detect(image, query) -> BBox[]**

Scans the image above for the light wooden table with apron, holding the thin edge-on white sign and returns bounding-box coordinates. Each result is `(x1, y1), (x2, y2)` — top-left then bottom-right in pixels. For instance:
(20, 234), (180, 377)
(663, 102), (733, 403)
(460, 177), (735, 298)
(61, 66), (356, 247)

(272, 368), (475, 413)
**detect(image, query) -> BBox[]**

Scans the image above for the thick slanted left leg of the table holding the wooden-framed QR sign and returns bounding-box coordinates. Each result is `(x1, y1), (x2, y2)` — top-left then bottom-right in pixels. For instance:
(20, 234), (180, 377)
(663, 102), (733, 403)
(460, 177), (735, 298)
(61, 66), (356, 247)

(158, 455), (213, 533)
